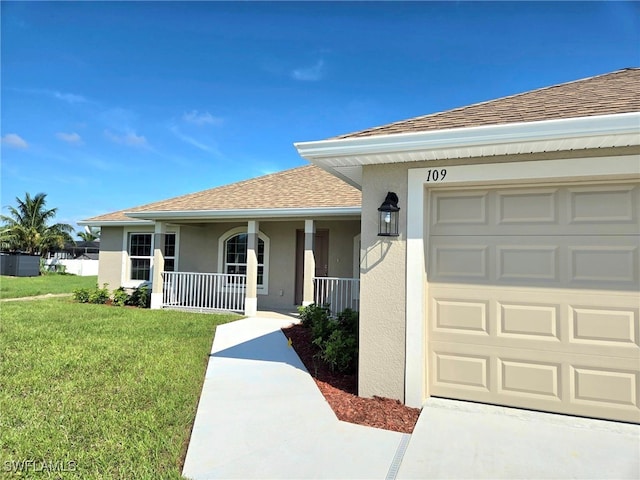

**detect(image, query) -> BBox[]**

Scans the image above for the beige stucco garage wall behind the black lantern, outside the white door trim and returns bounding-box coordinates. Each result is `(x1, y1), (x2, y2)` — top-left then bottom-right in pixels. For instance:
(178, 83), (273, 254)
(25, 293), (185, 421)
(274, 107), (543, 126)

(358, 147), (640, 401)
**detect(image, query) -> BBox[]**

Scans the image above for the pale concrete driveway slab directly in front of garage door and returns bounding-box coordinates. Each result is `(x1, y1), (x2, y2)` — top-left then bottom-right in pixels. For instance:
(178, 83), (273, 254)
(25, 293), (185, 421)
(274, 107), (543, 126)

(398, 398), (640, 479)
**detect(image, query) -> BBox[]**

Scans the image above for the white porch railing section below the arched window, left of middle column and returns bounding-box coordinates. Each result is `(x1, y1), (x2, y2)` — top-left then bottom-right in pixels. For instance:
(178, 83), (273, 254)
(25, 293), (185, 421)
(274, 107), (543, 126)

(162, 272), (247, 312)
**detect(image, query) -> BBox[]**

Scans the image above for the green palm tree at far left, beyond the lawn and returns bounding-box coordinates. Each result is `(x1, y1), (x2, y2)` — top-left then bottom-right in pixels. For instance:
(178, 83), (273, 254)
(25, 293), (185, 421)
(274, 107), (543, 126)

(0, 193), (74, 257)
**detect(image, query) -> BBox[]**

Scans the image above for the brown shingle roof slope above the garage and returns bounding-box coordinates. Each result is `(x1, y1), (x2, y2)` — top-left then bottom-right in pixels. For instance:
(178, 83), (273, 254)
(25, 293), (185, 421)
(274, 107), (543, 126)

(335, 68), (640, 139)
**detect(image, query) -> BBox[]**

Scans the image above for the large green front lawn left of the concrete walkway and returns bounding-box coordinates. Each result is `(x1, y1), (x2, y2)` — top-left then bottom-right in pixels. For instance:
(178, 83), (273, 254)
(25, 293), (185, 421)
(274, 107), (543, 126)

(0, 298), (239, 479)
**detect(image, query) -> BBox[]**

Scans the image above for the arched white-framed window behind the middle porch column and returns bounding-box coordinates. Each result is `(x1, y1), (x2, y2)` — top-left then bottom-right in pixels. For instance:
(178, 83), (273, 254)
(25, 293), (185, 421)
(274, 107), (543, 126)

(218, 228), (269, 294)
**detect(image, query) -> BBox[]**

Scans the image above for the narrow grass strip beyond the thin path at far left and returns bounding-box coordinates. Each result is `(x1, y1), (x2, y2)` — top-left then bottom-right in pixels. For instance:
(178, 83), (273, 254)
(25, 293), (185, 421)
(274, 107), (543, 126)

(0, 274), (97, 298)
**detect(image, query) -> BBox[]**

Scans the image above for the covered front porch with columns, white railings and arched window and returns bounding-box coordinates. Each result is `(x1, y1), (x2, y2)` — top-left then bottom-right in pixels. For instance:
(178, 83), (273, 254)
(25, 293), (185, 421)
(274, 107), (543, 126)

(145, 217), (360, 316)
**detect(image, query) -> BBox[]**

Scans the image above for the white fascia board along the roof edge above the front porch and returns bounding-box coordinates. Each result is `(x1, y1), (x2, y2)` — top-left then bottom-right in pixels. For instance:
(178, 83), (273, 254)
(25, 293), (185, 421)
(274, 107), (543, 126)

(127, 207), (362, 220)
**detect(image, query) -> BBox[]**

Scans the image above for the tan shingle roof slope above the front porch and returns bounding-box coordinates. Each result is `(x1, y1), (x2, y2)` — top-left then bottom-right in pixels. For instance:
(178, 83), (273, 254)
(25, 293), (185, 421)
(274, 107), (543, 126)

(85, 165), (362, 223)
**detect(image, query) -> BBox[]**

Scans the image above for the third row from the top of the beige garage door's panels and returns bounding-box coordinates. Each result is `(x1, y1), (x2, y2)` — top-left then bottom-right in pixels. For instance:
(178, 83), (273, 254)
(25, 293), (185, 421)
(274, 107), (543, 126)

(428, 284), (640, 356)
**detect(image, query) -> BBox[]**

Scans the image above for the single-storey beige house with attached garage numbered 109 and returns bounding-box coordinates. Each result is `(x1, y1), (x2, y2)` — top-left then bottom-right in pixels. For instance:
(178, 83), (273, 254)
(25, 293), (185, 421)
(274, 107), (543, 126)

(84, 68), (640, 423)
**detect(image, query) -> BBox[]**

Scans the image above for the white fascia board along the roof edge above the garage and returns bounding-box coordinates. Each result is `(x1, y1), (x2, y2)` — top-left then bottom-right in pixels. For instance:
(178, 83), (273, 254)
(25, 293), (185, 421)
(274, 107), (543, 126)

(294, 112), (640, 166)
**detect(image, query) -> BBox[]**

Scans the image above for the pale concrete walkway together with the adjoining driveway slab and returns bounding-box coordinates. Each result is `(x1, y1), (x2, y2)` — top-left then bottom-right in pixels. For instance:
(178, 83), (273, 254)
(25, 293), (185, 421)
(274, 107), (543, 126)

(183, 316), (640, 480)
